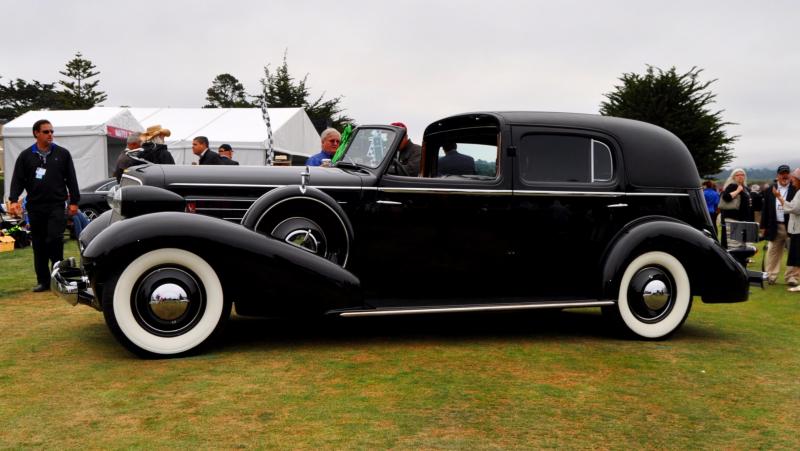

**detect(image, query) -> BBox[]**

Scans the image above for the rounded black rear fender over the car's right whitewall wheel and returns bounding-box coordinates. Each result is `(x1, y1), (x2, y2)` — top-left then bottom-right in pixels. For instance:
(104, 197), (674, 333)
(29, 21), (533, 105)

(601, 217), (749, 302)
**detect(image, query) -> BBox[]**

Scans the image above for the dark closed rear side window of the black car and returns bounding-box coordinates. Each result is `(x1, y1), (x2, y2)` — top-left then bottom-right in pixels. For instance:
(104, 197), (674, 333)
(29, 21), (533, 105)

(518, 134), (614, 183)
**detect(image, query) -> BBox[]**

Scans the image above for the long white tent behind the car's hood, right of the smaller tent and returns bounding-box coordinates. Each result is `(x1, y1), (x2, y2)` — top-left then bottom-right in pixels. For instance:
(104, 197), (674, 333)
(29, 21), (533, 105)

(92, 107), (320, 166)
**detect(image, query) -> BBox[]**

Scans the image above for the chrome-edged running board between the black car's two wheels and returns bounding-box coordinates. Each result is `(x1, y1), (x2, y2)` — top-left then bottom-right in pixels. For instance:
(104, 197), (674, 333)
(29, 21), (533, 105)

(331, 300), (617, 317)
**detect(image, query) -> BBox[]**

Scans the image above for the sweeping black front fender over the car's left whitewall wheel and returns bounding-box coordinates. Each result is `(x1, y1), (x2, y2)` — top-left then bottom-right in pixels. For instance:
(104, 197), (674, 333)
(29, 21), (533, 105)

(83, 212), (363, 313)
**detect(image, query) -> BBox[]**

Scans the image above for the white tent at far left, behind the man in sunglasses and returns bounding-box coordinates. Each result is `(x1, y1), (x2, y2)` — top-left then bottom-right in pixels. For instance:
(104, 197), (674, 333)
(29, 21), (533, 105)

(3, 108), (144, 193)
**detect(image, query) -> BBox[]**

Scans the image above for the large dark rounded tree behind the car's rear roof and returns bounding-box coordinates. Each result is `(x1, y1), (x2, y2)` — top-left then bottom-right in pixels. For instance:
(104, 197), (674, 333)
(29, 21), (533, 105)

(600, 66), (738, 176)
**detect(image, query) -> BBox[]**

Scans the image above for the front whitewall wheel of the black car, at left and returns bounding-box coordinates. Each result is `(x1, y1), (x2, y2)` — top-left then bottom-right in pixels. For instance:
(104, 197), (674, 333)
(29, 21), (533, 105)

(103, 249), (230, 357)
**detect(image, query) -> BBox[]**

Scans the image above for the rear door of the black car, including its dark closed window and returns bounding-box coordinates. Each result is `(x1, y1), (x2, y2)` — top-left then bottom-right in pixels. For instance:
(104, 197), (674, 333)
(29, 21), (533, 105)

(512, 126), (629, 299)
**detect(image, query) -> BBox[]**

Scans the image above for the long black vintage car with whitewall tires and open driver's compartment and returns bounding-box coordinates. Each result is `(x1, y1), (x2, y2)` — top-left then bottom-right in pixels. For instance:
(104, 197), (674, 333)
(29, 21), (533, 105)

(53, 112), (762, 355)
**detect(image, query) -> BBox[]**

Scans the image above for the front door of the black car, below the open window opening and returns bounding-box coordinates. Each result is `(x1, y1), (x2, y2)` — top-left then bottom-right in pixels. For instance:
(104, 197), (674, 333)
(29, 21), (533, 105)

(358, 138), (514, 303)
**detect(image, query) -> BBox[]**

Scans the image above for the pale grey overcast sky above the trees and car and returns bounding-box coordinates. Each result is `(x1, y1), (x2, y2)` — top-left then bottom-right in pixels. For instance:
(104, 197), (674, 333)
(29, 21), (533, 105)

(0, 0), (800, 167)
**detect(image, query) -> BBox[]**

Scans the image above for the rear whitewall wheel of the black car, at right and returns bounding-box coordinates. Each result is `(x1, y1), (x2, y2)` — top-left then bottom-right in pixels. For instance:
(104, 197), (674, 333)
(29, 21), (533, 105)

(605, 251), (692, 339)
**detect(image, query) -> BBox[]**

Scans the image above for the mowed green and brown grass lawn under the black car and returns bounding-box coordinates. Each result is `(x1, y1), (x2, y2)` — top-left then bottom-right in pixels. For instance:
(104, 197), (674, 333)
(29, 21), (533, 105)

(0, 242), (800, 449)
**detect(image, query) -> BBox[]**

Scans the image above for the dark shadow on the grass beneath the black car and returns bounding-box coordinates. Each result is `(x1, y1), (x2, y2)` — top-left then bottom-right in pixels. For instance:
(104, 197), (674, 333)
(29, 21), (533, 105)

(213, 309), (725, 350)
